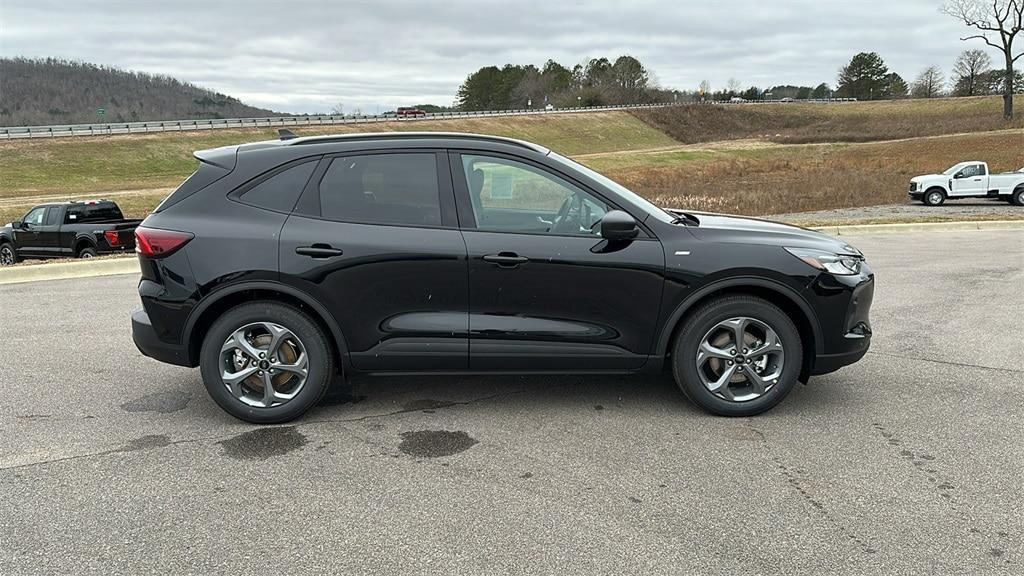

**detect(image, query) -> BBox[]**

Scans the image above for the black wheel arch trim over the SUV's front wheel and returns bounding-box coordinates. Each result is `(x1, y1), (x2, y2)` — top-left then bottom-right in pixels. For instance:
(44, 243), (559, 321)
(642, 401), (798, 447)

(654, 277), (824, 382)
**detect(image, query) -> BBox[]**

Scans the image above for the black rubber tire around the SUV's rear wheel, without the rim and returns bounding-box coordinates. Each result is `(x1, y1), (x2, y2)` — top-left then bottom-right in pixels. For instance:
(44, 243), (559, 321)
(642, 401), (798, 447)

(200, 301), (335, 424)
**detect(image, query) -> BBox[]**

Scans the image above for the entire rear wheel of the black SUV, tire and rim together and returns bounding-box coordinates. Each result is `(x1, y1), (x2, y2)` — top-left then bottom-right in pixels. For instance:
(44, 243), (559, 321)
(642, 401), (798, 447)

(200, 301), (335, 424)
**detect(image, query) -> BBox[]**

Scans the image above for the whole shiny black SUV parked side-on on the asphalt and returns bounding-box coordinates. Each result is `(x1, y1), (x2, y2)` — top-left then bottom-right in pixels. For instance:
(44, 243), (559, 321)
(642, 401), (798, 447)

(132, 132), (873, 423)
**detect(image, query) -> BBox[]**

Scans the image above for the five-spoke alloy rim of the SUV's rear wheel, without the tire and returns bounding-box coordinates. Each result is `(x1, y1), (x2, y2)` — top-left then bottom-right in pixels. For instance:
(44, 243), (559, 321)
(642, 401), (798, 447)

(220, 322), (309, 408)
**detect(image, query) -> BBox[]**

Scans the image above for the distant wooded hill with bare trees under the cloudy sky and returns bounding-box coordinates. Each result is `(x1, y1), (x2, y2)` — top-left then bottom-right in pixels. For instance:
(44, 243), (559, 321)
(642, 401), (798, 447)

(0, 58), (282, 126)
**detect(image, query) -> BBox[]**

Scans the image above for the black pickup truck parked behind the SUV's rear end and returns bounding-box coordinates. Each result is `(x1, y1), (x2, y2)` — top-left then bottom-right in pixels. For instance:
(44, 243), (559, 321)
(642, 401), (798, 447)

(0, 200), (142, 265)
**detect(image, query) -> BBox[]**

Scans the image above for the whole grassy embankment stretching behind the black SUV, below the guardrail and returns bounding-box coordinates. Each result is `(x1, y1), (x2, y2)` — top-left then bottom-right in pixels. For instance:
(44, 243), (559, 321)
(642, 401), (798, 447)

(0, 97), (1024, 221)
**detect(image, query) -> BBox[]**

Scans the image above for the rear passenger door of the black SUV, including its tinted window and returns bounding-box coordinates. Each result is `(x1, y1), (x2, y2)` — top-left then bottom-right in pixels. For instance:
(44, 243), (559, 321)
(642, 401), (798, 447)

(281, 149), (469, 372)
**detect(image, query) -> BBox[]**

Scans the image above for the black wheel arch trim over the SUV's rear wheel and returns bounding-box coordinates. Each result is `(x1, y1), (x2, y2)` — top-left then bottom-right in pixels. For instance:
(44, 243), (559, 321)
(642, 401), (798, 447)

(183, 281), (348, 369)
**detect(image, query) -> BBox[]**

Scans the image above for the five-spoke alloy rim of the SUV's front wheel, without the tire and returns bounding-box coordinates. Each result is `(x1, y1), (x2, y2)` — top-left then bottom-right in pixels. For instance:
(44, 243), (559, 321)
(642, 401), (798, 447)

(696, 317), (785, 402)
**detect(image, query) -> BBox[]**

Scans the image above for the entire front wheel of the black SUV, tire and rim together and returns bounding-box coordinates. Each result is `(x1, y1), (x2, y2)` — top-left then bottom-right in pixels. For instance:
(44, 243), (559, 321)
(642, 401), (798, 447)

(672, 295), (803, 416)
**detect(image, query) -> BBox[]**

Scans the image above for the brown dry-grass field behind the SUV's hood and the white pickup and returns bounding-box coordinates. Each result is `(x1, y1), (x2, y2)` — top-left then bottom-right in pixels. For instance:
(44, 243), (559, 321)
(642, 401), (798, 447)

(593, 130), (1024, 215)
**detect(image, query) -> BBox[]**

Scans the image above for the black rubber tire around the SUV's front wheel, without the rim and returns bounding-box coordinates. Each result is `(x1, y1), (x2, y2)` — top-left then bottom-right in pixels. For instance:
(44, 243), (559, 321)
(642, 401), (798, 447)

(672, 295), (804, 416)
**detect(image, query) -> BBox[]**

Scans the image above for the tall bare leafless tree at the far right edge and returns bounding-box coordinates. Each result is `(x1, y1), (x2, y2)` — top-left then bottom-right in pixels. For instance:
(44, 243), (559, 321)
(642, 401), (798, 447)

(942, 0), (1024, 120)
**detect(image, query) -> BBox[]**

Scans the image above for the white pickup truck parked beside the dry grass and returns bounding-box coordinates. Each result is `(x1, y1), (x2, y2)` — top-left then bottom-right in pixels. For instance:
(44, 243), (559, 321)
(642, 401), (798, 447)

(909, 162), (1024, 206)
